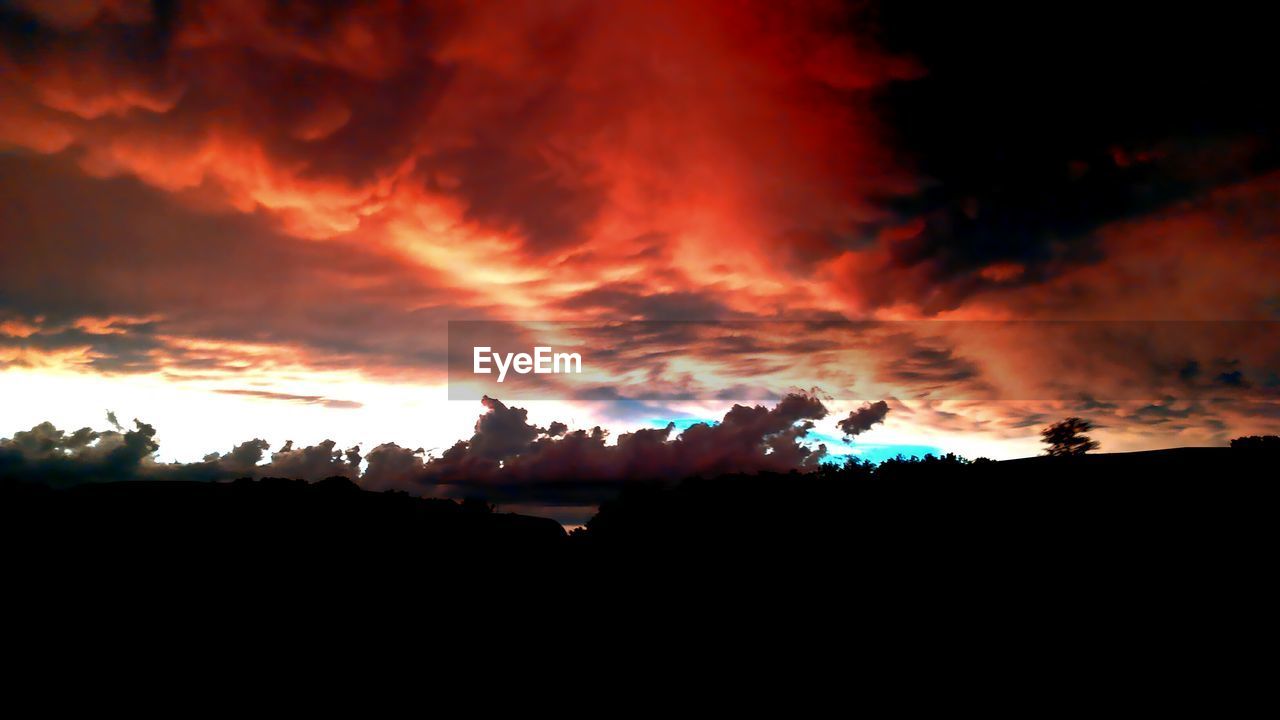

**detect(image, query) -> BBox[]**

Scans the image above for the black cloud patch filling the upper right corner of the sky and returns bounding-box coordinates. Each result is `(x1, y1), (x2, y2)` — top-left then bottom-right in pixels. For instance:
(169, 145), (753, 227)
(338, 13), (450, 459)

(867, 1), (1280, 311)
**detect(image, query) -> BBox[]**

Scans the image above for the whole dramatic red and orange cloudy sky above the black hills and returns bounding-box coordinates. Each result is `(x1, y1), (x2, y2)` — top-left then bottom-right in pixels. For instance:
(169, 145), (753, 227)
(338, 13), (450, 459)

(0, 0), (1280, 507)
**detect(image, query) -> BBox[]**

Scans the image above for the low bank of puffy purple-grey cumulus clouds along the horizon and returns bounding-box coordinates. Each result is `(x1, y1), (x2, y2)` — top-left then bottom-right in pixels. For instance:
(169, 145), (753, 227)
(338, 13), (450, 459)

(0, 393), (827, 497)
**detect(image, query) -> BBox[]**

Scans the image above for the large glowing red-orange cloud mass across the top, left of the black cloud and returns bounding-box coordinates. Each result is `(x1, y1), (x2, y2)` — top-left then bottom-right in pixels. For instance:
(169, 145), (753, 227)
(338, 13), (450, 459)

(0, 0), (919, 319)
